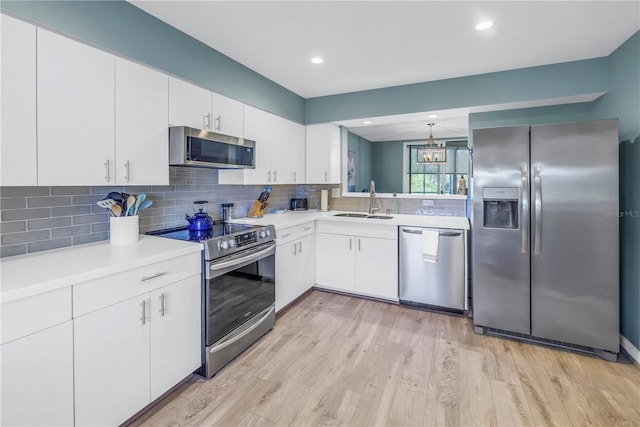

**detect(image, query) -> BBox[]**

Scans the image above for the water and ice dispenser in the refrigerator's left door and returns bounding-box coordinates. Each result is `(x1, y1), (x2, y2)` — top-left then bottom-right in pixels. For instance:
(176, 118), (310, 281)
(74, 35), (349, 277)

(482, 187), (520, 230)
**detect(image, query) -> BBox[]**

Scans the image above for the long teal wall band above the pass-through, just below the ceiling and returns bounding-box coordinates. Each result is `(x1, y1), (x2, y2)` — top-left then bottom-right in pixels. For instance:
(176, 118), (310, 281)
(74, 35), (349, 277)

(305, 58), (607, 123)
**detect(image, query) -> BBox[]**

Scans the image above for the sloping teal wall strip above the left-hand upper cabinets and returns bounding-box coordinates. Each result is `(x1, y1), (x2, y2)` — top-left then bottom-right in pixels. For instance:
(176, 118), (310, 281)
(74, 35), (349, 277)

(0, 0), (304, 123)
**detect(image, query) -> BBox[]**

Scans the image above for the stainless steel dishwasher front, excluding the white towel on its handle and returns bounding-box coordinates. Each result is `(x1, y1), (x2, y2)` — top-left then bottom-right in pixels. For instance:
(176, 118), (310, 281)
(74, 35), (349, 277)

(398, 226), (465, 312)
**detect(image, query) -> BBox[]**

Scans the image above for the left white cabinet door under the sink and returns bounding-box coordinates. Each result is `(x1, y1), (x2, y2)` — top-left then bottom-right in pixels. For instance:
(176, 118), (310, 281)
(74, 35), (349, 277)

(316, 233), (355, 292)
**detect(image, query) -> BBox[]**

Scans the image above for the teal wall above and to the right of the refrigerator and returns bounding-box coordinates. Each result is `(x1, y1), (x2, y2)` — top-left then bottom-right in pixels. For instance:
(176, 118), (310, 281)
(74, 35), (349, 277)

(469, 31), (640, 348)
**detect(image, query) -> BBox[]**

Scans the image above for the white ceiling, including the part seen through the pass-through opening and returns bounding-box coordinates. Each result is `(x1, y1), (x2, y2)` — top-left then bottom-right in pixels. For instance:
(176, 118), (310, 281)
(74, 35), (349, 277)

(130, 0), (640, 140)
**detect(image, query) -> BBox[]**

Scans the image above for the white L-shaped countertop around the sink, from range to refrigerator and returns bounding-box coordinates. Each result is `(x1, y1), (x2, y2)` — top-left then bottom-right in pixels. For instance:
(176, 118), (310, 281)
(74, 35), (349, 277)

(231, 210), (469, 230)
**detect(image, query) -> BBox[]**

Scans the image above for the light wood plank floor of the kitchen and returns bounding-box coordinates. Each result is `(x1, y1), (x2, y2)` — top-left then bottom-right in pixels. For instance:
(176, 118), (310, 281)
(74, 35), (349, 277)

(134, 291), (640, 427)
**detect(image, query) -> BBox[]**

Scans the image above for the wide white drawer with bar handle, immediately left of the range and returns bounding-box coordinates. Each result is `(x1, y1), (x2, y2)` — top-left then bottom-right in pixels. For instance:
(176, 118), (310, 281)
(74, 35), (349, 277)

(73, 253), (201, 318)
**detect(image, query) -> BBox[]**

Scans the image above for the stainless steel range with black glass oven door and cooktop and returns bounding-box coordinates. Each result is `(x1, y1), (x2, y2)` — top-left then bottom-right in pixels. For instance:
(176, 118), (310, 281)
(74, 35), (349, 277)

(148, 222), (276, 378)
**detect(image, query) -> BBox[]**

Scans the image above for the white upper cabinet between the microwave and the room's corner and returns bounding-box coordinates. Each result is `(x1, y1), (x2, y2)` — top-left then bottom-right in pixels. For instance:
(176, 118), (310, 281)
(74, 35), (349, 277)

(218, 105), (304, 185)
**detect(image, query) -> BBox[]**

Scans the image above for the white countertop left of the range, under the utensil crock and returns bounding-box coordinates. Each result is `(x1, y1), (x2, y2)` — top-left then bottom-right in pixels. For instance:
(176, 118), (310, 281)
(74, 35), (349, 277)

(0, 235), (203, 303)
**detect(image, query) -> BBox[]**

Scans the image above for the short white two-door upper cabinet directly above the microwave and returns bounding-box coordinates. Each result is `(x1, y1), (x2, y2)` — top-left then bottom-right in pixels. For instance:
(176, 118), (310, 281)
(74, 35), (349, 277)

(169, 77), (244, 138)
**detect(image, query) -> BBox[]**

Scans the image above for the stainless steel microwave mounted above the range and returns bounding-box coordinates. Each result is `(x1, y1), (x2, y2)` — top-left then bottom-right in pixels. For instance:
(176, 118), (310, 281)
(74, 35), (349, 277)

(169, 126), (256, 169)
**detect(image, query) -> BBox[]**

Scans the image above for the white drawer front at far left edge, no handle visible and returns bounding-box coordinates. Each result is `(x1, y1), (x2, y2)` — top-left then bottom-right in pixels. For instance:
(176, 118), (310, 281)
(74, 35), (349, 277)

(0, 287), (71, 344)
